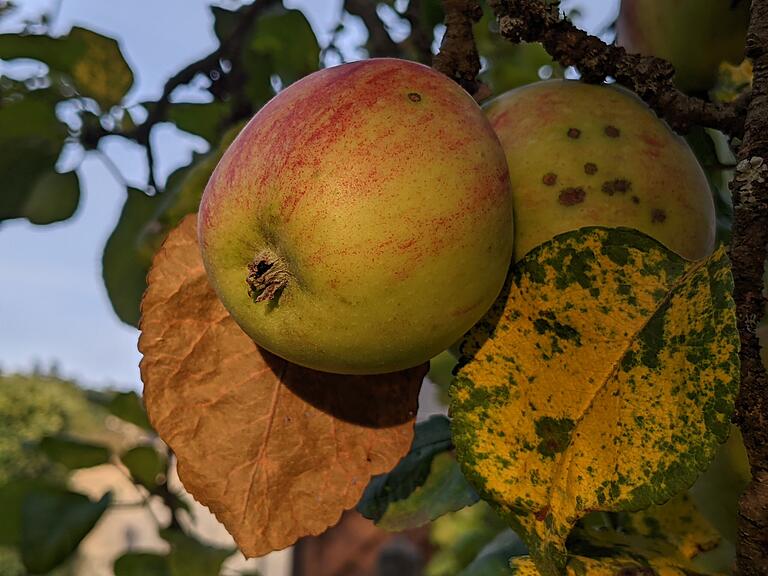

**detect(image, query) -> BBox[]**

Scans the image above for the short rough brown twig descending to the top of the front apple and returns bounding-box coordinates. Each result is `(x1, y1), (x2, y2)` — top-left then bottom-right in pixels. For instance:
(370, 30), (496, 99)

(432, 0), (483, 95)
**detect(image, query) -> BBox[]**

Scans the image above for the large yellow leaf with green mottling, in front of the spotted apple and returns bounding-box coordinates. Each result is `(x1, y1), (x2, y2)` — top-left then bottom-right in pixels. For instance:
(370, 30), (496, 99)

(451, 228), (739, 576)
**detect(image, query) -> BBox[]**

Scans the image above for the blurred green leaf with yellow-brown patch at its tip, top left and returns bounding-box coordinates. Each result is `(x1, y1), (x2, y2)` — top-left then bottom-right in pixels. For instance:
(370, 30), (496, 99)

(0, 27), (133, 110)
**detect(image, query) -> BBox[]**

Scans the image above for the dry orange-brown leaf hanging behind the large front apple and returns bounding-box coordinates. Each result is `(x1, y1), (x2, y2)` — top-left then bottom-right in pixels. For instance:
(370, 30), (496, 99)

(139, 216), (427, 556)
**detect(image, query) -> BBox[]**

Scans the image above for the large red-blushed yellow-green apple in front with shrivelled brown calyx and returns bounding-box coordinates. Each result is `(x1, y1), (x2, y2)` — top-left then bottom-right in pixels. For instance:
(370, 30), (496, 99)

(198, 59), (513, 374)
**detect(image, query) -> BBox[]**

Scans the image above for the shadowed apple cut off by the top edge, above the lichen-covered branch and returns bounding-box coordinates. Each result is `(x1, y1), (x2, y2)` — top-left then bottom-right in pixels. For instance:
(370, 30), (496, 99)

(616, 0), (750, 92)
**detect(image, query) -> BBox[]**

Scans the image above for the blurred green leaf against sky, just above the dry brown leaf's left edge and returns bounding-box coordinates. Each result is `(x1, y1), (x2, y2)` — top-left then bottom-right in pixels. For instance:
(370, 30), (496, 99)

(101, 188), (161, 326)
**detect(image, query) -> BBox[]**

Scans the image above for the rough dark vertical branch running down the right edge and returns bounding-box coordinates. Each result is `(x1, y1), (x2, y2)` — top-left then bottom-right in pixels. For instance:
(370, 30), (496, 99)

(730, 0), (768, 576)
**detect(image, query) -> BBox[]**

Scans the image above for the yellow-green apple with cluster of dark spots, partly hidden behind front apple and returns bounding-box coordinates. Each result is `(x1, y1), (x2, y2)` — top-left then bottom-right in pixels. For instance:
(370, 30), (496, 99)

(485, 80), (715, 260)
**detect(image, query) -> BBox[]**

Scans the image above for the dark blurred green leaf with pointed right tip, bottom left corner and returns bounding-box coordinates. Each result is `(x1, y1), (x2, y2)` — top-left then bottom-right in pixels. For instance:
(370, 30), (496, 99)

(20, 489), (112, 574)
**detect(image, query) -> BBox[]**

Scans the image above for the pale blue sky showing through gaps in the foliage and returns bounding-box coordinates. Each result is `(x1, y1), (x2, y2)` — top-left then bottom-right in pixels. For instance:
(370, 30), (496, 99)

(0, 0), (618, 390)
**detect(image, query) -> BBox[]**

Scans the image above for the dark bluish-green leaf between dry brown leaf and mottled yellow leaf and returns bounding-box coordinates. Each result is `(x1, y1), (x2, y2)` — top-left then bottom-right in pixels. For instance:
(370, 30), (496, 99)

(357, 416), (451, 522)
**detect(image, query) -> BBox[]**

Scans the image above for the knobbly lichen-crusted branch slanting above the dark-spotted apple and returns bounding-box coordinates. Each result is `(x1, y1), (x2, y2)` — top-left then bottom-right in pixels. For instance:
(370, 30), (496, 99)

(489, 0), (747, 137)
